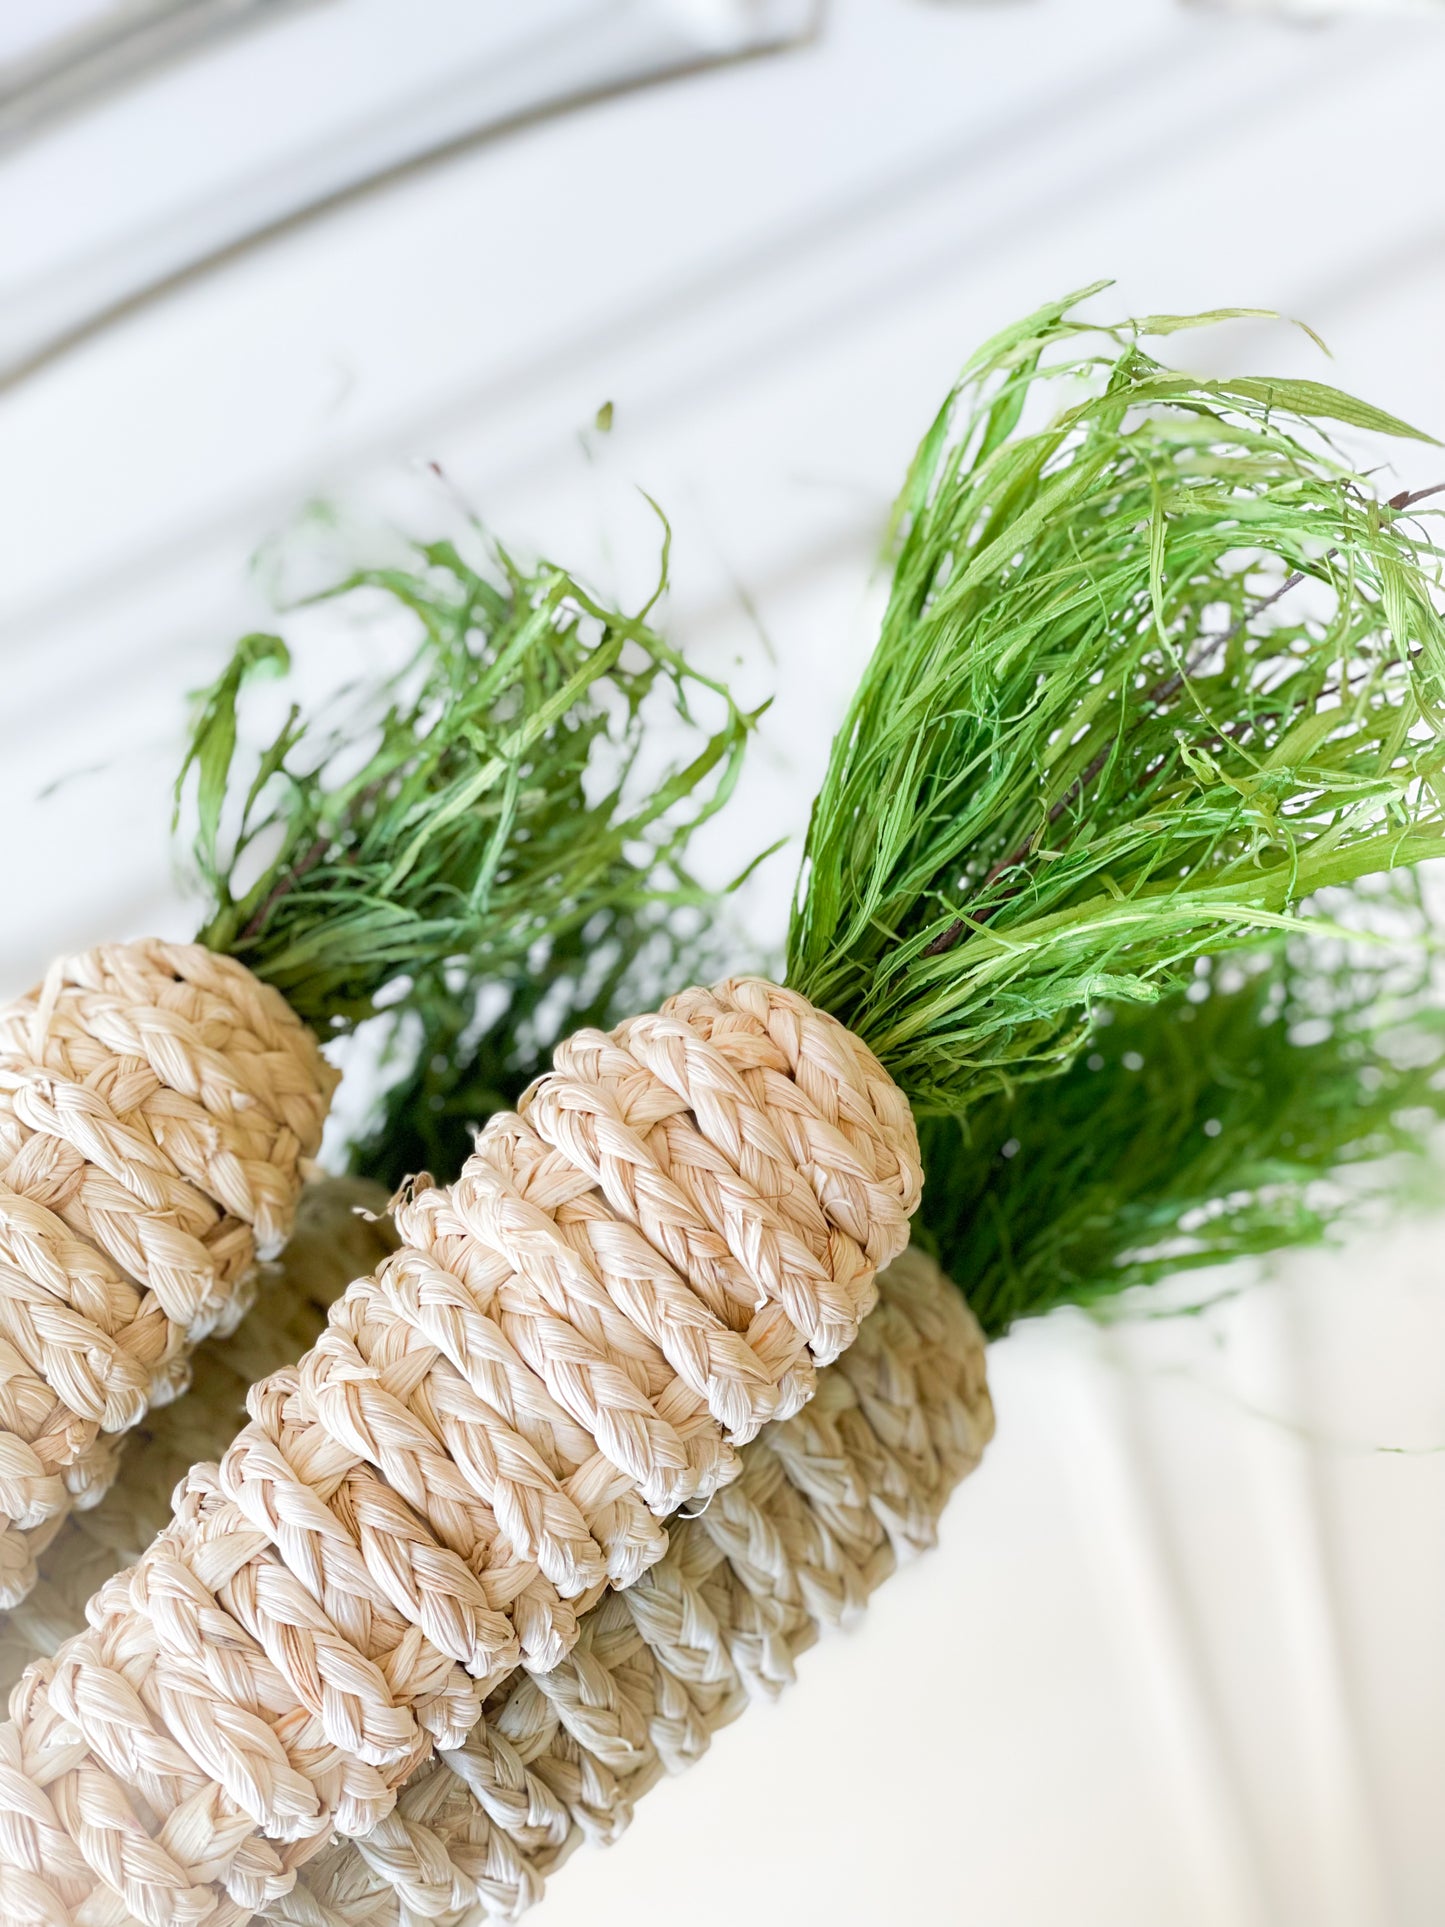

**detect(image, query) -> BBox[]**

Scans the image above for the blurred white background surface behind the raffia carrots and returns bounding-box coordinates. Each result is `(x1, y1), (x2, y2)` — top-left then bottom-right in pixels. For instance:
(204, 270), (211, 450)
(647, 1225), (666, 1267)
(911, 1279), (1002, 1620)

(0, 0), (1445, 1927)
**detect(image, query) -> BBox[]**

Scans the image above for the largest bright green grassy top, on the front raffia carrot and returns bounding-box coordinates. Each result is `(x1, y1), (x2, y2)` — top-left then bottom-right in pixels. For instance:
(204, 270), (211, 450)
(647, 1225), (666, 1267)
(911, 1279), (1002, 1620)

(788, 289), (1445, 1110)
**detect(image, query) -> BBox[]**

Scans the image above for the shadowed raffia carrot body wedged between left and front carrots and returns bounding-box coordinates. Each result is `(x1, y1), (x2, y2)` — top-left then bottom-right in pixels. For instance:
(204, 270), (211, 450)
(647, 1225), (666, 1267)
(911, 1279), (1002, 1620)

(0, 1177), (397, 1694)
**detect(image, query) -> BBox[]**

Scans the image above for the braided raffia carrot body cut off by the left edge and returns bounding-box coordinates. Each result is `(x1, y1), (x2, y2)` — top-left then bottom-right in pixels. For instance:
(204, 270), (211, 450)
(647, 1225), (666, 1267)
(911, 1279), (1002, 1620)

(0, 940), (335, 1605)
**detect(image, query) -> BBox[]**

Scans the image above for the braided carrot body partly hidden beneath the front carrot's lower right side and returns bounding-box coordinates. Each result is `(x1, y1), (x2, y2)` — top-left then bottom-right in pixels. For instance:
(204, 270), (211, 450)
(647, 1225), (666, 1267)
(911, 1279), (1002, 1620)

(266, 1251), (994, 1927)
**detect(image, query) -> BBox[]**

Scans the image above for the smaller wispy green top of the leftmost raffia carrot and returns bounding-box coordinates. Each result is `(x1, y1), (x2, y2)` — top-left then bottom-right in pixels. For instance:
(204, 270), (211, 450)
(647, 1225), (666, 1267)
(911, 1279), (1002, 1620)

(177, 541), (753, 1043)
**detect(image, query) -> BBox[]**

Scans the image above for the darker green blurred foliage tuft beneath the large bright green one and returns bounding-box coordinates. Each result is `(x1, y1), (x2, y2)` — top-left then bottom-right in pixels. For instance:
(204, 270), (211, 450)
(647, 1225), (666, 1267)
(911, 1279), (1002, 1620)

(915, 936), (1445, 1337)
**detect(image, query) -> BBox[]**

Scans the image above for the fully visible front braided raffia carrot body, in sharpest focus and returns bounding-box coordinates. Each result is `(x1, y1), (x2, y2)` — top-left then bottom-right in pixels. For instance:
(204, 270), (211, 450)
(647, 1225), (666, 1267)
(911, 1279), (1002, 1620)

(0, 979), (921, 1927)
